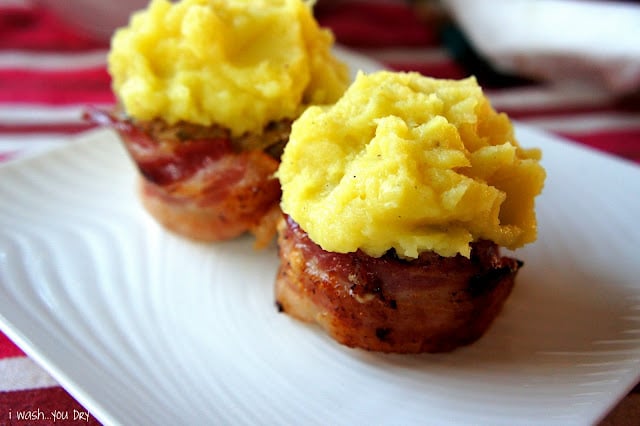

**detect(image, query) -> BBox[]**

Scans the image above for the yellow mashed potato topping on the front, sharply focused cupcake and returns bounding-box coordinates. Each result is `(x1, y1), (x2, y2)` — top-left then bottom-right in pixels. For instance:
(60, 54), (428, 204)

(278, 71), (545, 258)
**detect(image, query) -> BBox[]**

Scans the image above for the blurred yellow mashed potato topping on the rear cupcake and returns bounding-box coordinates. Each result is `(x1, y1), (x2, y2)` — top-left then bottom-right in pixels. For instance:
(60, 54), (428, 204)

(108, 0), (348, 135)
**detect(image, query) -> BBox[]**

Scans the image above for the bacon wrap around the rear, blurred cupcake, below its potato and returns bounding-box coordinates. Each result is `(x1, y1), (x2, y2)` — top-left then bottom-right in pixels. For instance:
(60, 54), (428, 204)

(85, 111), (290, 247)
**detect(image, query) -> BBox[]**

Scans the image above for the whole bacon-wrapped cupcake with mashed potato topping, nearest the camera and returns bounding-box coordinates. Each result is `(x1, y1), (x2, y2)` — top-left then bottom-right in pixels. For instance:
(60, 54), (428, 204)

(275, 71), (545, 353)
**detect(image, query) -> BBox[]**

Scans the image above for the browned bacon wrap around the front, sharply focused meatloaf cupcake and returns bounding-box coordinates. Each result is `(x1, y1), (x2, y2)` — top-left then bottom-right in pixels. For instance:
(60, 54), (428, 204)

(275, 217), (522, 353)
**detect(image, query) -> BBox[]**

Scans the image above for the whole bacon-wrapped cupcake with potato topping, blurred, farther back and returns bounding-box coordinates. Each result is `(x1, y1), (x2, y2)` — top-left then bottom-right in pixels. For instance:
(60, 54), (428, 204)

(92, 0), (348, 246)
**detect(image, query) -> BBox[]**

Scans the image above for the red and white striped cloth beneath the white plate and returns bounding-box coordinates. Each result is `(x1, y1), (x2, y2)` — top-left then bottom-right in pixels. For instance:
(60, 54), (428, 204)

(0, 0), (640, 425)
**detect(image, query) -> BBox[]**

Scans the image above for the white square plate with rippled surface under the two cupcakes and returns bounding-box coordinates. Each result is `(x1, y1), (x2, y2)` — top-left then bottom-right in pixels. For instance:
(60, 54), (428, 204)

(0, 56), (640, 425)
